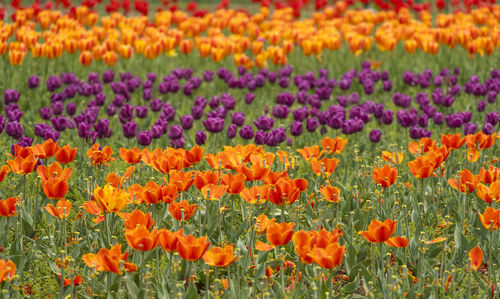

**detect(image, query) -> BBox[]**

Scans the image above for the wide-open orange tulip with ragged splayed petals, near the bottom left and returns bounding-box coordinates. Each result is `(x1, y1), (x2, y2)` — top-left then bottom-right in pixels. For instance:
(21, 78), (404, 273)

(82, 244), (137, 275)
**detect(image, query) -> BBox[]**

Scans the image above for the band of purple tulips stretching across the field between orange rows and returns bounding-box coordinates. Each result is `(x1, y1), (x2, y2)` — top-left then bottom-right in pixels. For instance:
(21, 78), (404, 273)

(0, 62), (500, 147)
